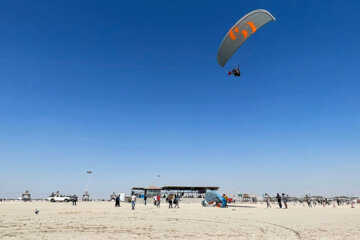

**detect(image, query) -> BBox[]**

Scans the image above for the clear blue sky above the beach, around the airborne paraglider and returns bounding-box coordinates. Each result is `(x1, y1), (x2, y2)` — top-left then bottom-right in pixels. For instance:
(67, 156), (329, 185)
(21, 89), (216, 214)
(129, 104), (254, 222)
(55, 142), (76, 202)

(0, 0), (360, 197)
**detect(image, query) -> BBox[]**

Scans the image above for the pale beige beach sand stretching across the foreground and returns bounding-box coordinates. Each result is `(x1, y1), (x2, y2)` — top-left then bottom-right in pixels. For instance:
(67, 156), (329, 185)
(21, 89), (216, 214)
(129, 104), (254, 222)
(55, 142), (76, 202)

(0, 202), (360, 240)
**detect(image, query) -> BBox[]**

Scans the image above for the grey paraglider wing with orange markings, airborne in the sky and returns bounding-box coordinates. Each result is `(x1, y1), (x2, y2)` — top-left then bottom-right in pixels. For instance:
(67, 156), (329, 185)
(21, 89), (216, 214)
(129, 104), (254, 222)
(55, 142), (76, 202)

(217, 9), (275, 67)
